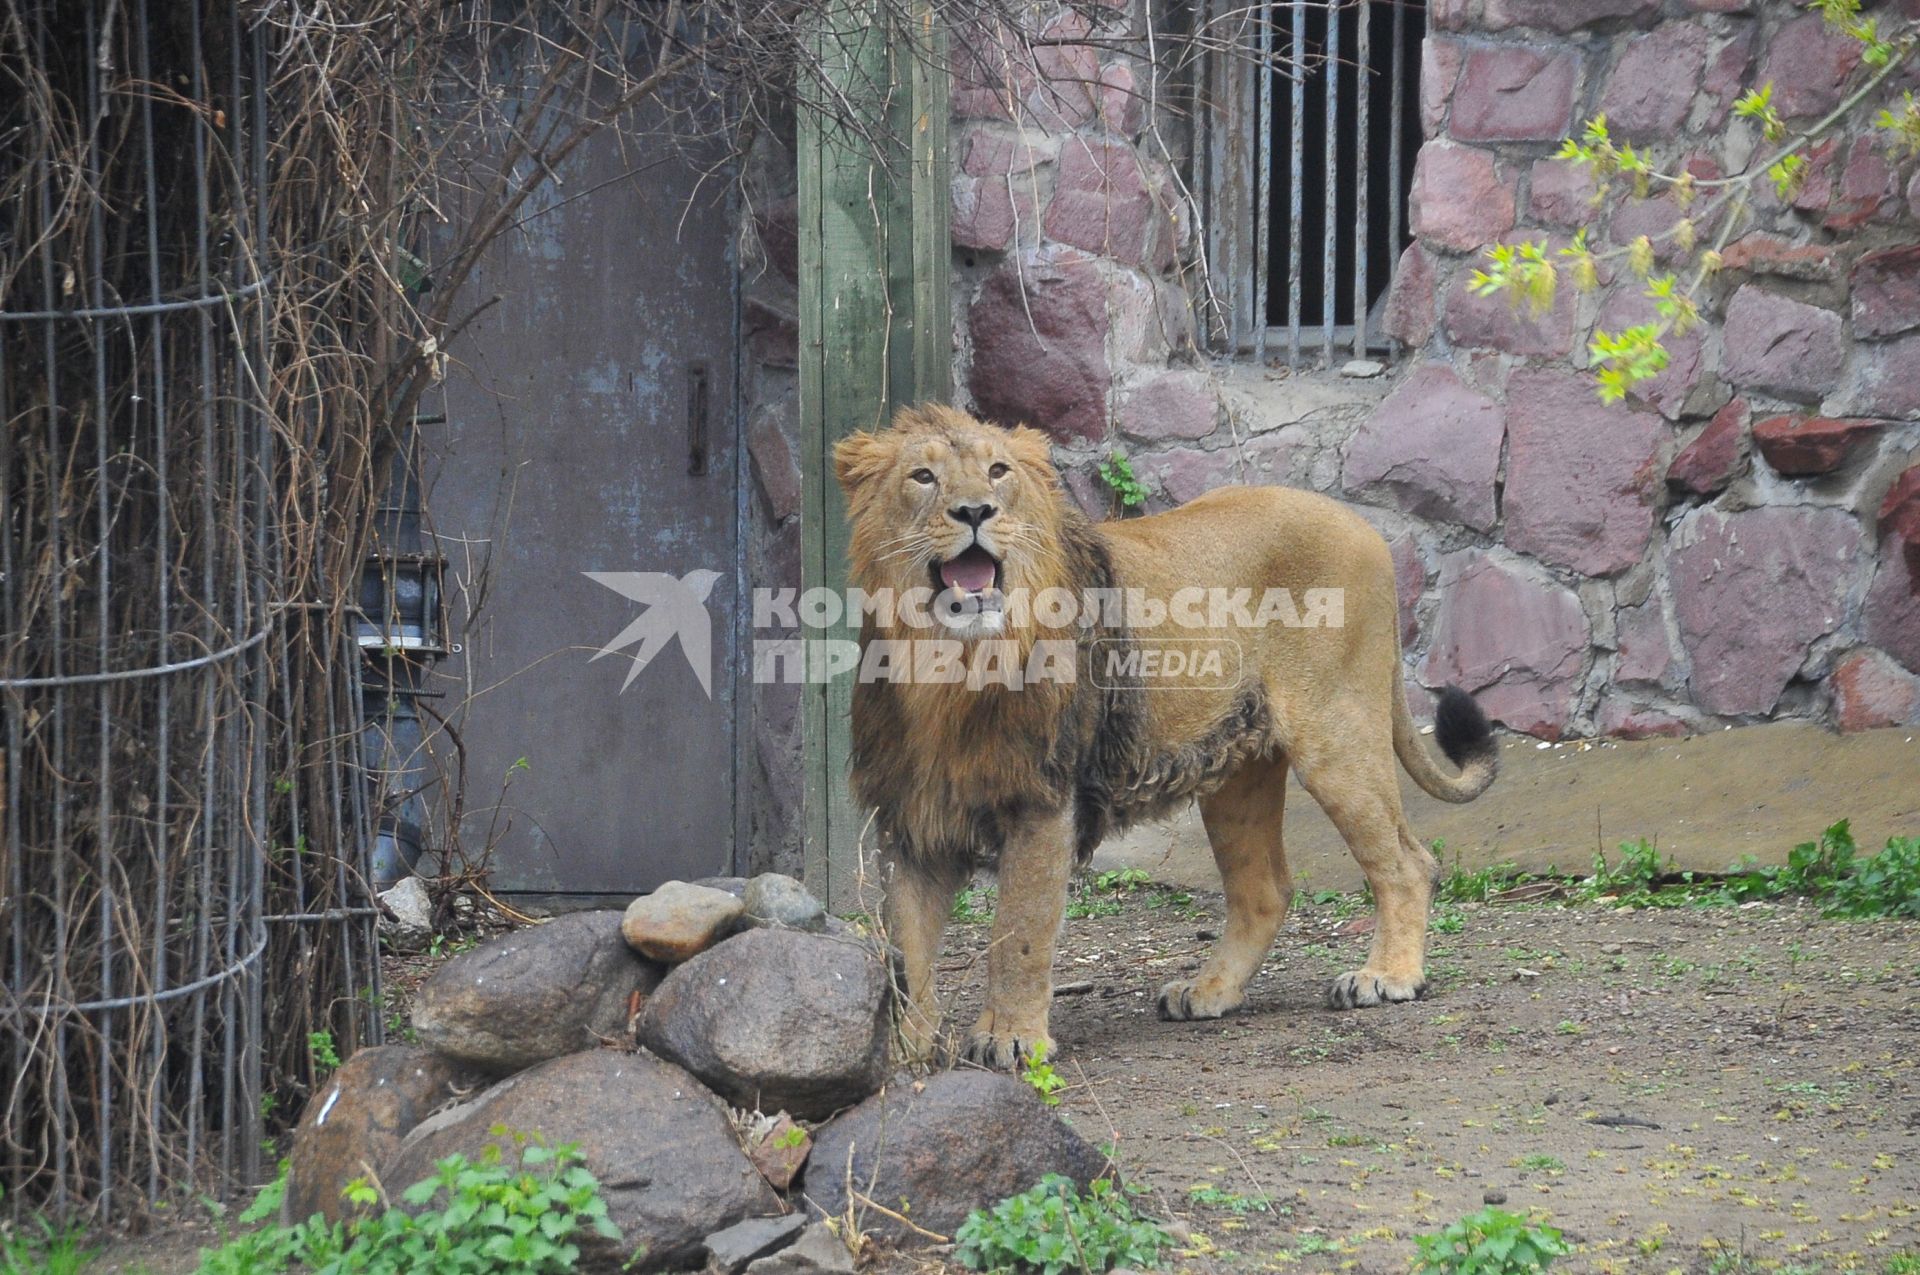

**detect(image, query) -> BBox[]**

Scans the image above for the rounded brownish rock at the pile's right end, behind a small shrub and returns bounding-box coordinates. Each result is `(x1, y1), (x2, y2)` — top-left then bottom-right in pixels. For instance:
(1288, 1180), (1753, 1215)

(806, 1071), (1106, 1242)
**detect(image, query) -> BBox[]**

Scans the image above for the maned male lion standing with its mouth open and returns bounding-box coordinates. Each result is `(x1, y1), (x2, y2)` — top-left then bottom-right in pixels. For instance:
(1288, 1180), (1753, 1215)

(833, 405), (1498, 1068)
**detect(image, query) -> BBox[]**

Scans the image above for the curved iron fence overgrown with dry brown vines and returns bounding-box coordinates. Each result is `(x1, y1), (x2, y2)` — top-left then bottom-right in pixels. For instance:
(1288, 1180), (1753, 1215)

(0, 0), (380, 1215)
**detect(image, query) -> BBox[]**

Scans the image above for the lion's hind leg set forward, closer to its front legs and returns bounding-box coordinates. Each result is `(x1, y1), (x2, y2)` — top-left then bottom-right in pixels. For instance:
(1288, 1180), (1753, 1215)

(1158, 757), (1294, 1020)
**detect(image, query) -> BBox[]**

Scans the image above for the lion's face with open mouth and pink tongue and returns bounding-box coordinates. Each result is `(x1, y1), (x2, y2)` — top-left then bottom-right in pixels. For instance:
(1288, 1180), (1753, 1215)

(833, 407), (1062, 639)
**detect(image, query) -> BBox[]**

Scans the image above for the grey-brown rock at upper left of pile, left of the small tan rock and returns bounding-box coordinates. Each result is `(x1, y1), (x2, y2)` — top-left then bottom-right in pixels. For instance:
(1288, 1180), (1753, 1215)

(413, 912), (660, 1075)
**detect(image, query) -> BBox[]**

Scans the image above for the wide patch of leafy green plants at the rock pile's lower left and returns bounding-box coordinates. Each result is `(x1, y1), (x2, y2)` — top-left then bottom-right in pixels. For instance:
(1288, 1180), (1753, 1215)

(192, 1127), (620, 1275)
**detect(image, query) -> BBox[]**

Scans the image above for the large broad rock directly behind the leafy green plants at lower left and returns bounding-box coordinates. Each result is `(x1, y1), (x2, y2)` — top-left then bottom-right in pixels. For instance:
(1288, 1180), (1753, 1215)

(382, 1048), (780, 1271)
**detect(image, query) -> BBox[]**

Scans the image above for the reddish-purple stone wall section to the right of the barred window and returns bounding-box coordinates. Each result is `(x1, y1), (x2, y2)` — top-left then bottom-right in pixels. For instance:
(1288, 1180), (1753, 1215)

(1367, 0), (1920, 737)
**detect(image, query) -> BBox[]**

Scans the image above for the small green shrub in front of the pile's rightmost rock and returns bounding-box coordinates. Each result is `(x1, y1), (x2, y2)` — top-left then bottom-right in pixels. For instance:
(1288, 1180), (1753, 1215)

(954, 1173), (1173, 1275)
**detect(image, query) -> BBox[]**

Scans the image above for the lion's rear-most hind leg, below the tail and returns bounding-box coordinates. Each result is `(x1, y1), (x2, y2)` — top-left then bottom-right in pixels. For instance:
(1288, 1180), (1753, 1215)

(1300, 735), (1434, 1010)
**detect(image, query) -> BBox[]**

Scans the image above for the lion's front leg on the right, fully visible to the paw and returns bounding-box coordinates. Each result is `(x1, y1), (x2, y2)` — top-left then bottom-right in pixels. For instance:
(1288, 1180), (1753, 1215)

(964, 810), (1073, 1070)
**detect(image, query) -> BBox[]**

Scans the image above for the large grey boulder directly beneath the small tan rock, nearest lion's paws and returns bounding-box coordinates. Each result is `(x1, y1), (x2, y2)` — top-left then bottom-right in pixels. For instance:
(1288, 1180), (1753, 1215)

(639, 929), (893, 1119)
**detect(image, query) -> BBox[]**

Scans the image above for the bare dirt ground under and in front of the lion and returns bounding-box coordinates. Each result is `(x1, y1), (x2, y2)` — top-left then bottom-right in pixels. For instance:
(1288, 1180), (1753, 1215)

(925, 891), (1920, 1271)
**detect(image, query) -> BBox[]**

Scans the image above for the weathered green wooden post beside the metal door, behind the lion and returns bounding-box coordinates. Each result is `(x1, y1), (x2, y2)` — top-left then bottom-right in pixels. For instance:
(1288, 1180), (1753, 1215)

(799, 0), (952, 906)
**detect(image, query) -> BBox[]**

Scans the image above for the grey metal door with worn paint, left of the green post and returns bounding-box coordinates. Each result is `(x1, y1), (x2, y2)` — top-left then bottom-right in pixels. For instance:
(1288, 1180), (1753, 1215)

(422, 124), (739, 895)
